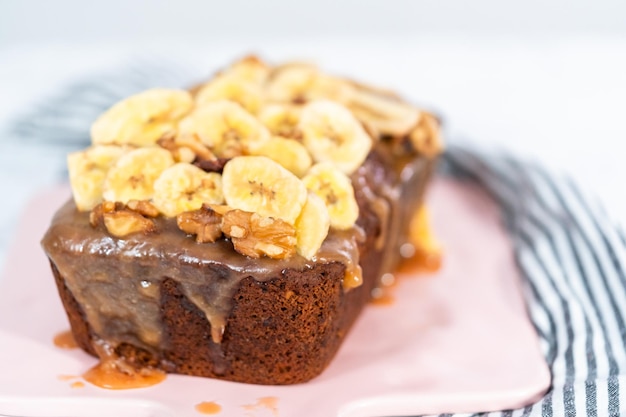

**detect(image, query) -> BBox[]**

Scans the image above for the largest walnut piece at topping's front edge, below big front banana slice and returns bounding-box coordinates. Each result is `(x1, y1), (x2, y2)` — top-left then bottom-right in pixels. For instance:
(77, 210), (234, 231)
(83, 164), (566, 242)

(222, 210), (296, 259)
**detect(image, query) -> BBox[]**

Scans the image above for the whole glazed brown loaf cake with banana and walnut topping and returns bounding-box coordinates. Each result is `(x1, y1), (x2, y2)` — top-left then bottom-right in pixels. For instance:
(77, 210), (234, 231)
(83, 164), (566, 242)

(42, 58), (441, 384)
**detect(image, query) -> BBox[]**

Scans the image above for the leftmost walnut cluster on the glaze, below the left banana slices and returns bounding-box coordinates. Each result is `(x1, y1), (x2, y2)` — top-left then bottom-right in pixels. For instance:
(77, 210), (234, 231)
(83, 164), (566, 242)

(89, 200), (159, 237)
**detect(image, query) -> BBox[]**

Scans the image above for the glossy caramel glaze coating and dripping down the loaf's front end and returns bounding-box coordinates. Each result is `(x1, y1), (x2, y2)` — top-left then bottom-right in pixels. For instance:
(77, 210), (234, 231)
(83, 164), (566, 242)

(43, 202), (363, 352)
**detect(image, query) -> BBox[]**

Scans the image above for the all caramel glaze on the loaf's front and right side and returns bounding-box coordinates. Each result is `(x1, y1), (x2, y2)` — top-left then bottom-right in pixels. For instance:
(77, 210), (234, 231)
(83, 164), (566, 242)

(42, 144), (434, 374)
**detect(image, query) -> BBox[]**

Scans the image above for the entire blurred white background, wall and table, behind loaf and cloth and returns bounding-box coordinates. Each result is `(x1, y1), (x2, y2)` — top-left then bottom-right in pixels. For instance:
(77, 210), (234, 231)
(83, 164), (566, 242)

(0, 0), (626, 270)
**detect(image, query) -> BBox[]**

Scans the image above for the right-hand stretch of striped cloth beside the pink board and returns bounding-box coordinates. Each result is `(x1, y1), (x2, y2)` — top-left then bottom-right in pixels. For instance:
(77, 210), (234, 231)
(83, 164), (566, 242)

(446, 147), (626, 416)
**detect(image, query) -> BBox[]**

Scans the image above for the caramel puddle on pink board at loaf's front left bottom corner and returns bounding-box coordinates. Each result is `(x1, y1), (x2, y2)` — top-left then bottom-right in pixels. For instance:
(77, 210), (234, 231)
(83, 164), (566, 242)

(83, 342), (166, 390)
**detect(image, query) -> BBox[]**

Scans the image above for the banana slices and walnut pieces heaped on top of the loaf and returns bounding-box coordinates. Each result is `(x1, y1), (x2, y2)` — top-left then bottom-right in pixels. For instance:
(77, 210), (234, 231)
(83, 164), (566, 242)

(67, 57), (441, 259)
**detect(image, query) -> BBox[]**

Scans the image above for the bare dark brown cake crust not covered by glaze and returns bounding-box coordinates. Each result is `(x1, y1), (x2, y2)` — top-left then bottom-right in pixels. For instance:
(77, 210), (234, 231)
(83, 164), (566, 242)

(52, 152), (434, 385)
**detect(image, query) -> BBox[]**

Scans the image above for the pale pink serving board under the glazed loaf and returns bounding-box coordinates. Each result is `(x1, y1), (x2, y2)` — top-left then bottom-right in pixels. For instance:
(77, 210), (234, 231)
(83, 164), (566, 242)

(0, 180), (550, 417)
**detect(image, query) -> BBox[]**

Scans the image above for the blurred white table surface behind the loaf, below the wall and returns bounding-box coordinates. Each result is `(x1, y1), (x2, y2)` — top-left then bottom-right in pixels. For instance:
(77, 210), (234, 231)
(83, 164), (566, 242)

(0, 35), (626, 272)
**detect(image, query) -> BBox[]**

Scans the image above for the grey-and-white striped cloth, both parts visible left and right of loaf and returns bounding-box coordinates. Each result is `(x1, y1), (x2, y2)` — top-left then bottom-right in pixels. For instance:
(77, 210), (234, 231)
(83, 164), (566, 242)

(11, 65), (626, 417)
